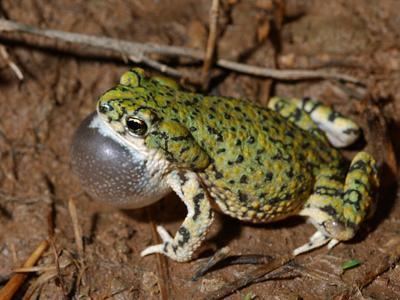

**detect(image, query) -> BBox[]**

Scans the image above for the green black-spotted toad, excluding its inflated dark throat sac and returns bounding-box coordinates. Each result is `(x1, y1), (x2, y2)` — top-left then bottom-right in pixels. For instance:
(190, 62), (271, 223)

(98, 68), (378, 261)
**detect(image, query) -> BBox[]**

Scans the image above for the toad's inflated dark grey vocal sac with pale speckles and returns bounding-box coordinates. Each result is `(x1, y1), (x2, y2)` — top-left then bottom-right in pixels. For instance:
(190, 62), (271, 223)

(71, 112), (170, 208)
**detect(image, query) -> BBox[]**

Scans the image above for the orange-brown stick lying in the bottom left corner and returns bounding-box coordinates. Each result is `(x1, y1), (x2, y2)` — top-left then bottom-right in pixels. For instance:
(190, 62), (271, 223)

(0, 240), (49, 300)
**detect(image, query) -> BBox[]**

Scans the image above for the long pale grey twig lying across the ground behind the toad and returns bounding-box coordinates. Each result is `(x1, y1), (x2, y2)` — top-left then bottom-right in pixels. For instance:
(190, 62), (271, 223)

(0, 18), (365, 85)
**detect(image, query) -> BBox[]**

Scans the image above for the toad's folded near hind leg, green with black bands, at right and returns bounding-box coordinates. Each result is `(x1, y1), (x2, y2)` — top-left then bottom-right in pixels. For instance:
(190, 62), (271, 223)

(293, 152), (379, 255)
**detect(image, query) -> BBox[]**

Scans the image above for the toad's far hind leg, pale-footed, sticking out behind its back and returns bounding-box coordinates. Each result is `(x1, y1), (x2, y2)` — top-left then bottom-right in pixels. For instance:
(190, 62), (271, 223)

(268, 97), (360, 147)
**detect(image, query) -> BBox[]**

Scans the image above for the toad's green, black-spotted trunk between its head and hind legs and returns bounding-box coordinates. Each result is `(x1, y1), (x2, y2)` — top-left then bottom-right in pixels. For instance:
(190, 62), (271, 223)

(176, 92), (343, 222)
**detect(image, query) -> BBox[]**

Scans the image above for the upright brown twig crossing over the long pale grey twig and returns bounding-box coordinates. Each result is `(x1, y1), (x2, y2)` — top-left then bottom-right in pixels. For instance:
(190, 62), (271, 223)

(201, 0), (219, 90)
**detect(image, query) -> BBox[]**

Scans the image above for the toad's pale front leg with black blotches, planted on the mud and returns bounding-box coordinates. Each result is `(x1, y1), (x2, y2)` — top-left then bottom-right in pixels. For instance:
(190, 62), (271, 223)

(141, 170), (214, 262)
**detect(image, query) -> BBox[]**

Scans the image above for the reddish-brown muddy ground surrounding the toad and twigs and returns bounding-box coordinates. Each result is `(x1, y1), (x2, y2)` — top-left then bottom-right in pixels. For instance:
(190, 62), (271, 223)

(0, 0), (400, 299)
